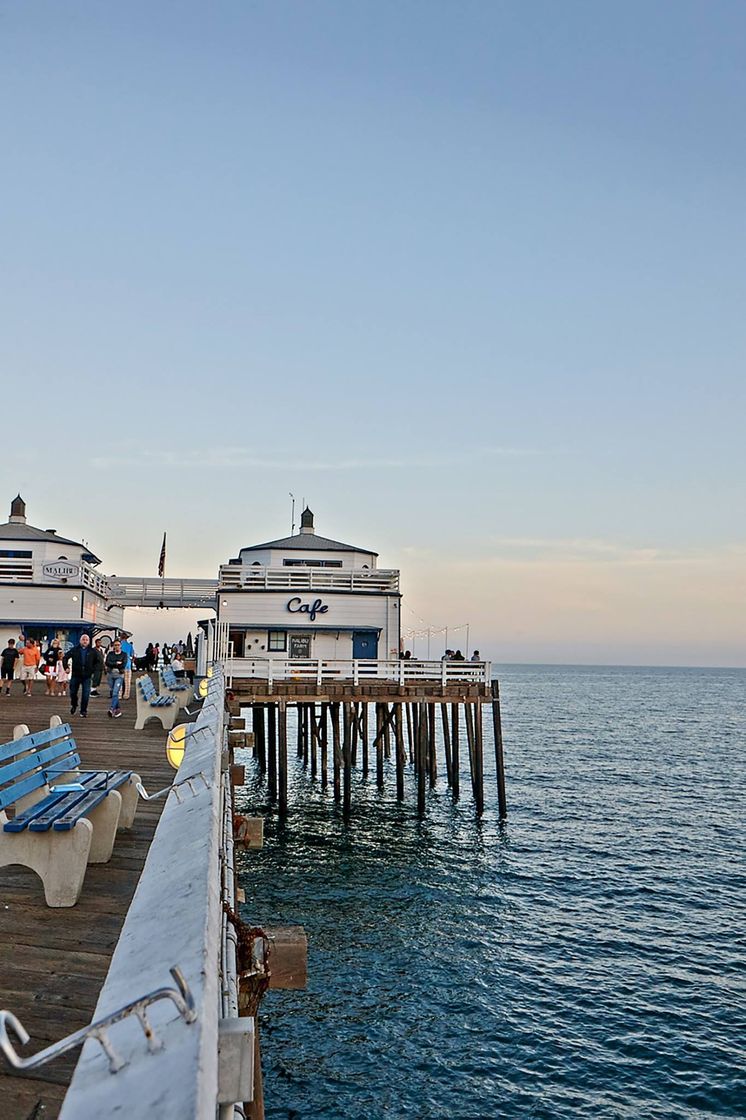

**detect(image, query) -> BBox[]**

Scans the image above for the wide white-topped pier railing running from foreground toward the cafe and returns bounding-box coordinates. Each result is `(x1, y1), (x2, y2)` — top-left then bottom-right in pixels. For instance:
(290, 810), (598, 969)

(60, 665), (246, 1120)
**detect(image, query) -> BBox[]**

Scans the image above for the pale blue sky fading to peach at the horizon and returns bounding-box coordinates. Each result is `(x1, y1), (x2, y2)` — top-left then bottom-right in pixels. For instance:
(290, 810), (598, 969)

(0, 0), (746, 666)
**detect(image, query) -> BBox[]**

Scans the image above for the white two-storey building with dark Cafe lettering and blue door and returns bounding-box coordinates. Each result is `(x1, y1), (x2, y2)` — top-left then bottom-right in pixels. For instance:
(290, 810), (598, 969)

(217, 508), (401, 661)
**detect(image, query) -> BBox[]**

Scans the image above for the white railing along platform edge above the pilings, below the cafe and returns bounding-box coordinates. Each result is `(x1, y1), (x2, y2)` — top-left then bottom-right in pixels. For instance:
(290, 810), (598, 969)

(226, 657), (492, 689)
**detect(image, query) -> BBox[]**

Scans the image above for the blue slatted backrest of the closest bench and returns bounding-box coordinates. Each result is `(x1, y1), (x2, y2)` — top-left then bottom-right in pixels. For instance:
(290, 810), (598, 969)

(0, 724), (81, 811)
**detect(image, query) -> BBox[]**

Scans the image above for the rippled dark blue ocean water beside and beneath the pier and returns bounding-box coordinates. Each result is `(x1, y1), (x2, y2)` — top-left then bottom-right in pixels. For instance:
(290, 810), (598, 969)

(234, 666), (746, 1120)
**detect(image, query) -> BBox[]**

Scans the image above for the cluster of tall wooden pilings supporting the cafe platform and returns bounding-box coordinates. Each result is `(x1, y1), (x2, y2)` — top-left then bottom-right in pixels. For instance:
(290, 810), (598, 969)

(241, 681), (507, 820)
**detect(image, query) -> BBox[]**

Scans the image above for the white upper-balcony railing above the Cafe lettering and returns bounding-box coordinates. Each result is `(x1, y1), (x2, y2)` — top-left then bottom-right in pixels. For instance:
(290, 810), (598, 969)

(218, 563), (399, 592)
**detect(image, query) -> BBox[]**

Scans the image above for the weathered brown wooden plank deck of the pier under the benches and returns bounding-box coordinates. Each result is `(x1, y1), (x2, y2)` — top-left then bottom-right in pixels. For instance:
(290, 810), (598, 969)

(0, 683), (174, 1120)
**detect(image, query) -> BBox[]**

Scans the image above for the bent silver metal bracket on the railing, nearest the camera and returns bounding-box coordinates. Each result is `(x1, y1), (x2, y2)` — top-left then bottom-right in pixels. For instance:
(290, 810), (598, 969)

(0, 964), (197, 1073)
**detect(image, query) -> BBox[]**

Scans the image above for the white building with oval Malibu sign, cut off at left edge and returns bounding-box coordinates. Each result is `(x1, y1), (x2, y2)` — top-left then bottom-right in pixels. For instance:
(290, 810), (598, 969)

(0, 494), (123, 648)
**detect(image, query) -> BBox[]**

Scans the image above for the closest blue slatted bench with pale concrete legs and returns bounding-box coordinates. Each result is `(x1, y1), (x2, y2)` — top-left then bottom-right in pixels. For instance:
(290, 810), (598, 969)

(0, 717), (140, 906)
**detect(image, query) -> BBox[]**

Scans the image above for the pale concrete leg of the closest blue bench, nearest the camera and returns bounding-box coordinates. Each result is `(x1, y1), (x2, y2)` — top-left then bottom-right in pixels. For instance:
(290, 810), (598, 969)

(0, 819), (93, 907)
